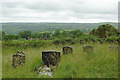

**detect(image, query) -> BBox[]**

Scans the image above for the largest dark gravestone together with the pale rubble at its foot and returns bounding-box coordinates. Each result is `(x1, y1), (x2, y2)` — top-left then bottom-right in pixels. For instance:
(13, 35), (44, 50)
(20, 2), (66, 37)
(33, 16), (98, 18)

(38, 51), (60, 77)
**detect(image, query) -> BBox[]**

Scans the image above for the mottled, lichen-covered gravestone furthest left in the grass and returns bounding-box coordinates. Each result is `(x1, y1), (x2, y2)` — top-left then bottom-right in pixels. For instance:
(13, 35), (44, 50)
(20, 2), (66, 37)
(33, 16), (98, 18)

(12, 51), (25, 67)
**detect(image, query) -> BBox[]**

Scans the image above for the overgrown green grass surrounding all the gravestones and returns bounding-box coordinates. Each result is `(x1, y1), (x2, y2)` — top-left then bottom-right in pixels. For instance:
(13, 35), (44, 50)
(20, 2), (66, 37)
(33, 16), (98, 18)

(2, 44), (118, 78)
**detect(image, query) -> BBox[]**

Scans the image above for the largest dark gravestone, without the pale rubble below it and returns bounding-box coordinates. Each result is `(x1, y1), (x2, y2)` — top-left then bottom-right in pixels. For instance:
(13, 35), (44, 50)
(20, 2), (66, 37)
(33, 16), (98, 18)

(42, 51), (60, 67)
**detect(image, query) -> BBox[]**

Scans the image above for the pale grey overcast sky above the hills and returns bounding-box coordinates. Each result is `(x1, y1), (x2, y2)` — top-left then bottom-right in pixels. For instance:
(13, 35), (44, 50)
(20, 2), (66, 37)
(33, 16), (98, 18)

(0, 0), (119, 23)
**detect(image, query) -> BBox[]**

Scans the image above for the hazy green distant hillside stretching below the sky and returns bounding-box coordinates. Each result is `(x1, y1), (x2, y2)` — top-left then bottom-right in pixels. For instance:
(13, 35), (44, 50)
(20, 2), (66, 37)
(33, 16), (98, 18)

(2, 22), (118, 34)
